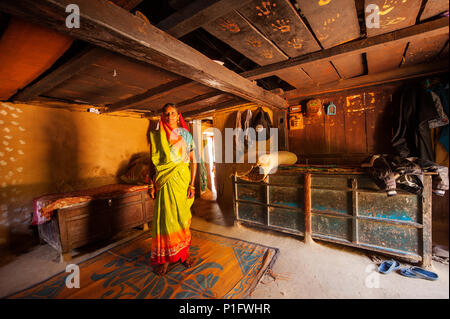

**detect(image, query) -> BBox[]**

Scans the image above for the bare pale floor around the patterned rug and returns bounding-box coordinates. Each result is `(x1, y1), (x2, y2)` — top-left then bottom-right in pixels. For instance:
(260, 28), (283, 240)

(0, 200), (449, 299)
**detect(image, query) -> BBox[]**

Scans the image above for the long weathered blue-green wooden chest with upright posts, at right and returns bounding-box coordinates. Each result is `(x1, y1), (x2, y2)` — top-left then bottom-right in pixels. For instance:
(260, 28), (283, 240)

(233, 170), (432, 267)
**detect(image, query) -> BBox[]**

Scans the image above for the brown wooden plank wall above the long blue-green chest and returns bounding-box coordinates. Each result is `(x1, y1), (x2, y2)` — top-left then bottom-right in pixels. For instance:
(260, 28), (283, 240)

(288, 84), (400, 164)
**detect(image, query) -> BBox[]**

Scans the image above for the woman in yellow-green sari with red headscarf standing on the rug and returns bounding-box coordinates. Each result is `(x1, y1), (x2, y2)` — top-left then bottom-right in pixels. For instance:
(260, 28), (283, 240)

(149, 103), (197, 275)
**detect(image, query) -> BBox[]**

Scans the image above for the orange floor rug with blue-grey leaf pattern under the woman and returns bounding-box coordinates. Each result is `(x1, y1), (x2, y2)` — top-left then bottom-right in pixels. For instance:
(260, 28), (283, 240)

(7, 229), (279, 299)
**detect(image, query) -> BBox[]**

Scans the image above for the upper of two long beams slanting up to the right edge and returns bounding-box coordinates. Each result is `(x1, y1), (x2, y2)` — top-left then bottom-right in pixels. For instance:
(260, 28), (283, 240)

(240, 17), (449, 80)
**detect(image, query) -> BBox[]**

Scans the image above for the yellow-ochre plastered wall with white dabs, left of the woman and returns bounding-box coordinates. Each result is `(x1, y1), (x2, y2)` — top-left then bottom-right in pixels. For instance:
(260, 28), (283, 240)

(0, 103), (149, 249)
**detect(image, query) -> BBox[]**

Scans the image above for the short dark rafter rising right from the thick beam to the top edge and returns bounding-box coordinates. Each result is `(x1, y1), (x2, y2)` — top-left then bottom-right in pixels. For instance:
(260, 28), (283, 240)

(157, 0), (249, 38)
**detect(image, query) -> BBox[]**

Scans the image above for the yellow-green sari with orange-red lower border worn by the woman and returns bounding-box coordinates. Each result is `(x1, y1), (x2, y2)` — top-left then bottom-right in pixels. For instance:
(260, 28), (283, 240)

(150, 122), (194, 265)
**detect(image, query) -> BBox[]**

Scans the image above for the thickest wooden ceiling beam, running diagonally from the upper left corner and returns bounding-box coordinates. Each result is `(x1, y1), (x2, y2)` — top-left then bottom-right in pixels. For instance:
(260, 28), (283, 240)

(0, 0), (286, 108)
